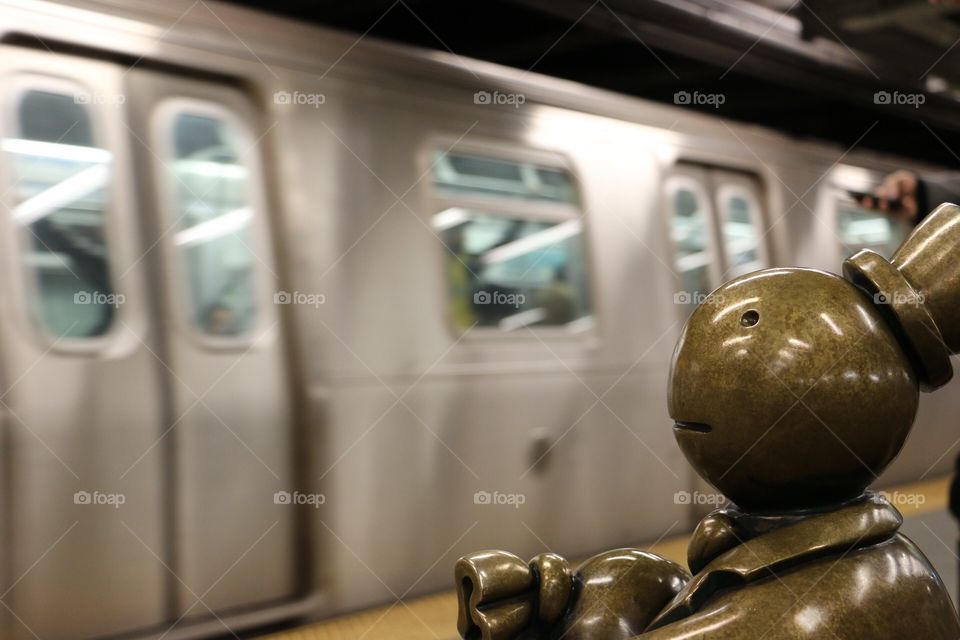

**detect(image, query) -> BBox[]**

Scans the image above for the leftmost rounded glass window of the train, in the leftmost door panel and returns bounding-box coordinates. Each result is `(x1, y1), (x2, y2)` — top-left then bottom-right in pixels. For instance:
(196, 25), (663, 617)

(2, 90), (117, 338)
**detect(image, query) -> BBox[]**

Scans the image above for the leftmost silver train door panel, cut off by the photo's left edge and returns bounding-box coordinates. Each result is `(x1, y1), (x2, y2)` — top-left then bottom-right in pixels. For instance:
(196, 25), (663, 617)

(0, 46), (168, 640)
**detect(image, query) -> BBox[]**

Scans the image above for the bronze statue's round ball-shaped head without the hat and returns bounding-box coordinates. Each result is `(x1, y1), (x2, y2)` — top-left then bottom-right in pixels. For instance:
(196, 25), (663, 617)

(668, 269), (919, 511)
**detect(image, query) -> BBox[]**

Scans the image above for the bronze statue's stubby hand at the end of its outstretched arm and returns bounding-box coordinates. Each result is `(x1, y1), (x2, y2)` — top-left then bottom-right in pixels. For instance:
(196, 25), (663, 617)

(455, 551), (573, 640)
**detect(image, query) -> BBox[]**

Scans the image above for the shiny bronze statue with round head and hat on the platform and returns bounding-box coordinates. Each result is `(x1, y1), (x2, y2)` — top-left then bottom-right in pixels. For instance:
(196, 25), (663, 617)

(456, 204), (960, 640)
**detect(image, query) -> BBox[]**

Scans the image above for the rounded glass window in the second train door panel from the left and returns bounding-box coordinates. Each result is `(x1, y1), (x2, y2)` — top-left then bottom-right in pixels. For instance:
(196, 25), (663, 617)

(170, 113), (257, 336)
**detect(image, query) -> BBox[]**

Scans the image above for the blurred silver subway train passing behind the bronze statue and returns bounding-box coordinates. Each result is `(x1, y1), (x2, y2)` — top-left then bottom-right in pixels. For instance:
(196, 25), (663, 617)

(0, 0), (960, 640)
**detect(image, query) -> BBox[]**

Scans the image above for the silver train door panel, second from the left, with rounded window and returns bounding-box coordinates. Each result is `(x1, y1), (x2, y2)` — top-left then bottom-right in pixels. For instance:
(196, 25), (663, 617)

(127, 70), (297, 619)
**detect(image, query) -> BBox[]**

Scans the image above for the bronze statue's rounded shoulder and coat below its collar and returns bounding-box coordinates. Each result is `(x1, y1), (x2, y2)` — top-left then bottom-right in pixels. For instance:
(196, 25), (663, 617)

(637, 533), (960, 640)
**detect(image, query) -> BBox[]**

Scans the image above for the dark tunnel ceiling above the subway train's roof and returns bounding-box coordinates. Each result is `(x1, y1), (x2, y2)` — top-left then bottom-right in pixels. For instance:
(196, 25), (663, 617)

(227, 0), (960, 166)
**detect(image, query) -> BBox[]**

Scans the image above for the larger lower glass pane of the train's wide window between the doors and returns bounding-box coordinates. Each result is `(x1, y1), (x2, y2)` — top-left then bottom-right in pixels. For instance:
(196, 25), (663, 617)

(433, 207), (590, 332)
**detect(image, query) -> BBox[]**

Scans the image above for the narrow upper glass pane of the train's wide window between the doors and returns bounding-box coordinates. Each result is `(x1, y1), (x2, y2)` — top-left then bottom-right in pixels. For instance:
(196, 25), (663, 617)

(433, 152), (576, 204)
